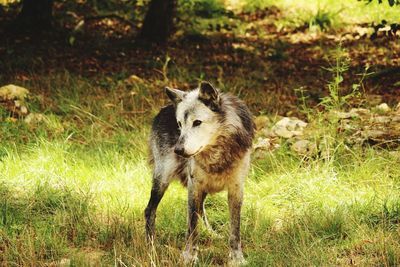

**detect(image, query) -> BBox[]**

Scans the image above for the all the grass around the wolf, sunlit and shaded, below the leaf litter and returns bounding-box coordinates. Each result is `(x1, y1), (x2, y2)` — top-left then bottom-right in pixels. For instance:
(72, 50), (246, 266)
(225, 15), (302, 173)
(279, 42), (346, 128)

(0, 68), (400, 266)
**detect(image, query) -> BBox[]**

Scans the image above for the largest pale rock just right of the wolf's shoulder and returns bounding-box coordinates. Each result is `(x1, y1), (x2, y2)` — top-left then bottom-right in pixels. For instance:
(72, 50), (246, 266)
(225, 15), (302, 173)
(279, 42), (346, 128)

(272, 117), (307, 138)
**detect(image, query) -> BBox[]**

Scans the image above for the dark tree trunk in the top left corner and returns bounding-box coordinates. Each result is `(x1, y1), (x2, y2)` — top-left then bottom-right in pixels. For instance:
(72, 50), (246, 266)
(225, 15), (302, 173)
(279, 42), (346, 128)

(15, 0), (53, 32)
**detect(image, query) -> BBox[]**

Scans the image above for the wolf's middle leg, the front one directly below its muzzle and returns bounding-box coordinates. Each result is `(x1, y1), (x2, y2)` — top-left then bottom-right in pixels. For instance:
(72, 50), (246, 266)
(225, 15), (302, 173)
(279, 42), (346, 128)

(183, 178), (204, 264)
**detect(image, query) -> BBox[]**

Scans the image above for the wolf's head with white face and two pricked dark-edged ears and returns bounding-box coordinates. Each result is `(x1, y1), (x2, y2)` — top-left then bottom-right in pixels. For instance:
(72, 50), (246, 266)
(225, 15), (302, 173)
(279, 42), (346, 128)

(166, 82), (221, 157)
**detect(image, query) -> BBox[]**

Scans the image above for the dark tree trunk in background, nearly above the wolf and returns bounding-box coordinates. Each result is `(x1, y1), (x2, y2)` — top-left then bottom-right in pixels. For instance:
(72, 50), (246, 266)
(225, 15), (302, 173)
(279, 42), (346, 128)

(140, 0), (176, 43)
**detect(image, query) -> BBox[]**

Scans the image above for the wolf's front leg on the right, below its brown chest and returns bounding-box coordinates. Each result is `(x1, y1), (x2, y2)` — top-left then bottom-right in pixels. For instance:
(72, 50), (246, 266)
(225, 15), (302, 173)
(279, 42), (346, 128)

(228, 184), (246, 266)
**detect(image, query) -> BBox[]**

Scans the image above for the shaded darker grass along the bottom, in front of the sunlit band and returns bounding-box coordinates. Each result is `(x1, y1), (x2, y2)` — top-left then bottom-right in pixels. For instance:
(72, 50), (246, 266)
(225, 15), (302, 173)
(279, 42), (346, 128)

(0, 180), (400, 266)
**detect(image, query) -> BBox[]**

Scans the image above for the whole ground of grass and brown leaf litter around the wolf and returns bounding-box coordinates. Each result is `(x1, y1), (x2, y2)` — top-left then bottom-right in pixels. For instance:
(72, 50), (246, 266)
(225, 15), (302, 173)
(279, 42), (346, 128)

(0, 1), (400, 266)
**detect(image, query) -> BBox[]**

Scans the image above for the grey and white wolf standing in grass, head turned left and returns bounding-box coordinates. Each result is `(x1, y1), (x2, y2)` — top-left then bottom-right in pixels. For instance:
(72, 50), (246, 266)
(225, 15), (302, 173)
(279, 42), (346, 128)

(144, 82), (255, 265)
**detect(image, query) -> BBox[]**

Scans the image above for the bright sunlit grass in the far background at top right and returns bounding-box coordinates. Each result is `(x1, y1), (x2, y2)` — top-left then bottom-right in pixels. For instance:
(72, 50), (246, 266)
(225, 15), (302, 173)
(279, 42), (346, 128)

(217, 0), (400, 37)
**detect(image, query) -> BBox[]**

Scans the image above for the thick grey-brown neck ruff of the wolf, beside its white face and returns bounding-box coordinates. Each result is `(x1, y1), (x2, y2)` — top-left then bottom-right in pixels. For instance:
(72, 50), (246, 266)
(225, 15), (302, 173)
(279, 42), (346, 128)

(194, 94), (254, 174)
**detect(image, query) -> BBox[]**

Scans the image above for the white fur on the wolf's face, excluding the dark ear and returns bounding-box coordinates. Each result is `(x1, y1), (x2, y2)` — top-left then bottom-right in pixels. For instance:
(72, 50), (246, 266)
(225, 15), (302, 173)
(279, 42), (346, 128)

(176, 90), (220, 155)
